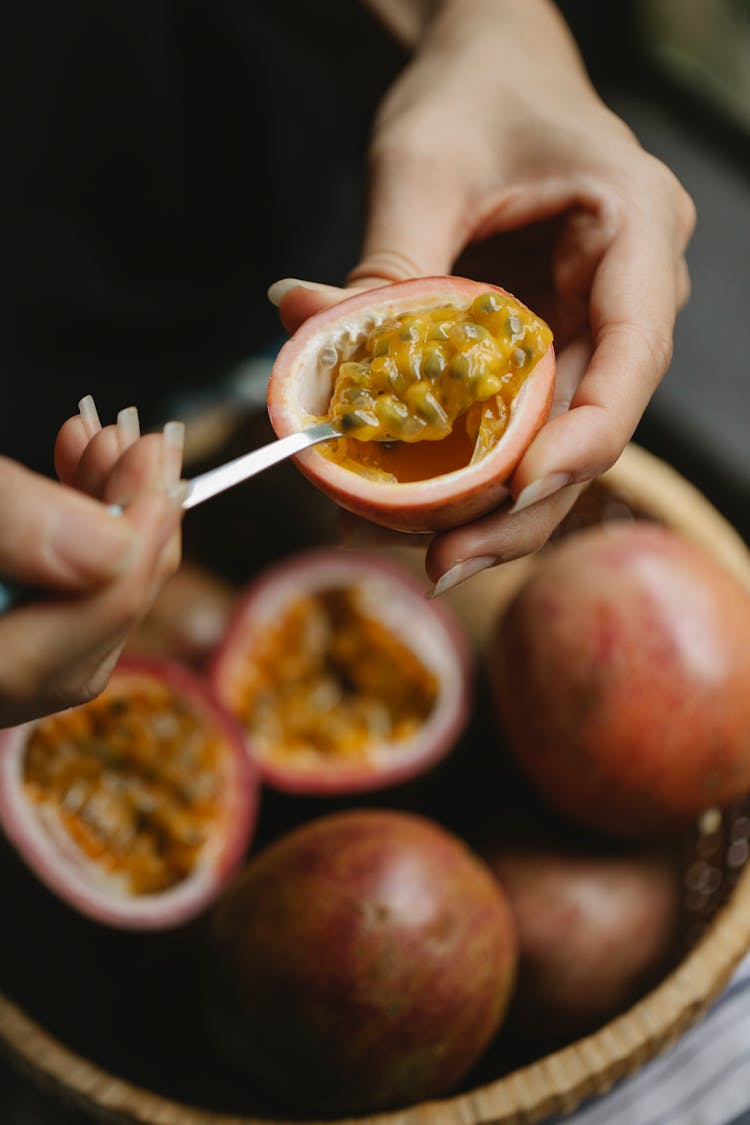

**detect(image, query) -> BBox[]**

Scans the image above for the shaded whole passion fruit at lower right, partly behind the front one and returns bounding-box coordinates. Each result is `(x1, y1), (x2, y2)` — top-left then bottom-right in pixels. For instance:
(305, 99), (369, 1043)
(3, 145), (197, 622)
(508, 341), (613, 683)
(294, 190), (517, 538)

(486, 847), (680, 1038)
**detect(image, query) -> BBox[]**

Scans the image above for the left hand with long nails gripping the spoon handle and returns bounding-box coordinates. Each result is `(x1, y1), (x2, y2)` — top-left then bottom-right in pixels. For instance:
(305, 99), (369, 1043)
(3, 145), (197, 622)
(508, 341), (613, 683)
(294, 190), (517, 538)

(0, 401), (182, 726)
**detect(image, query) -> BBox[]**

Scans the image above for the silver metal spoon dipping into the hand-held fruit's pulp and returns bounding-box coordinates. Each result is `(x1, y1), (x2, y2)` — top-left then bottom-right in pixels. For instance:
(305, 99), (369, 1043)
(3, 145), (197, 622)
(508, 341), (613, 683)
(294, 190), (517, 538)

(0, 422), (341, 615)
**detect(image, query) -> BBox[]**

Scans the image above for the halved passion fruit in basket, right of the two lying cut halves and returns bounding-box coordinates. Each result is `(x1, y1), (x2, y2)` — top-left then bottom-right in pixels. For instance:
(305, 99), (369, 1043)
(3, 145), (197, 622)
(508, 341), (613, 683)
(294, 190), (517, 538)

(211, 548), (470, 793)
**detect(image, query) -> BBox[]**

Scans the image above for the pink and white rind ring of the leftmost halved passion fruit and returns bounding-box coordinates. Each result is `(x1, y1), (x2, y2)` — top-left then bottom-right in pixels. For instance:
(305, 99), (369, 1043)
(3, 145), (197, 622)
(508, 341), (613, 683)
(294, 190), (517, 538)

(0, 656), (260, 930)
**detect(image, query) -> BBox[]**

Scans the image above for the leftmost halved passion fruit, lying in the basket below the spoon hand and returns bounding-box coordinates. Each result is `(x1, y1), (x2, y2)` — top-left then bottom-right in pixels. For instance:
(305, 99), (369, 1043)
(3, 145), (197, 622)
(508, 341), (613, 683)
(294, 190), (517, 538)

(0, 657), (259, 929)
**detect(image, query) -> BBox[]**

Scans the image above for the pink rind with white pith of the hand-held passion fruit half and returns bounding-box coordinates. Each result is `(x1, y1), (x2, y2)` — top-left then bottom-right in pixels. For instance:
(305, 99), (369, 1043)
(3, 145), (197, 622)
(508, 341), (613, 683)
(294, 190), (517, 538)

(268, 277), (555, 533)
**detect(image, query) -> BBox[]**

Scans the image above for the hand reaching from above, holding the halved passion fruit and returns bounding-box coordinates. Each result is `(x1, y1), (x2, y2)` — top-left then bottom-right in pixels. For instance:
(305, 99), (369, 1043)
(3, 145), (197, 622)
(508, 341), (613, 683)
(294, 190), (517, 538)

(266, 0), (695, 591)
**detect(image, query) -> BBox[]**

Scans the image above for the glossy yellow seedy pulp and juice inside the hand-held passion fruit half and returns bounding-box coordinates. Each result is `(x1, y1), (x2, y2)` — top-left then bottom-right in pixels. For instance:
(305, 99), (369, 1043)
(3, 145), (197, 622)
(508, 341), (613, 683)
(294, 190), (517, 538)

(320, 291), (552, 482)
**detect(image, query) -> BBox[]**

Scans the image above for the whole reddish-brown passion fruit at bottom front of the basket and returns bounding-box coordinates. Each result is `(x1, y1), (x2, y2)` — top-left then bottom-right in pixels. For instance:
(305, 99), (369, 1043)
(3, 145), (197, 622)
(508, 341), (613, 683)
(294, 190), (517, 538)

(211, 810), (516, 1115)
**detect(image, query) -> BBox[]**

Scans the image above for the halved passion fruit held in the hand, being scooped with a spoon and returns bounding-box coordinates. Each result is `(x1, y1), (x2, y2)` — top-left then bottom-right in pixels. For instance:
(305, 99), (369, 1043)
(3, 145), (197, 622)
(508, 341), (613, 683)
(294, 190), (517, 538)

(269, 278), (554, 532)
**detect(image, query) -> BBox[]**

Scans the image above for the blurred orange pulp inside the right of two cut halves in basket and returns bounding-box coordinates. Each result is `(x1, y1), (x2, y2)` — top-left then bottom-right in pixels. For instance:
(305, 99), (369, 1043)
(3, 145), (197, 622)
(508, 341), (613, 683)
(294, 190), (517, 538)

(233, 587), (439, 762)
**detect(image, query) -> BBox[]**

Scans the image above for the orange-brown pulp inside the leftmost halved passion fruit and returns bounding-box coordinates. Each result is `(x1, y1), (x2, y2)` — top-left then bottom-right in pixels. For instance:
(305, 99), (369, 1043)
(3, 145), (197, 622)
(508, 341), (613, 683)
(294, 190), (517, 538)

(24, 681), (219, 894)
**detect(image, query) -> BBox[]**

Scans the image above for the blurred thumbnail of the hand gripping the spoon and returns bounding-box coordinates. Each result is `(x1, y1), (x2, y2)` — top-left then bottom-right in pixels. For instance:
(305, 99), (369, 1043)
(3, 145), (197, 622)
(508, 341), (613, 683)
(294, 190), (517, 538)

(48, 509), (134, 579)
